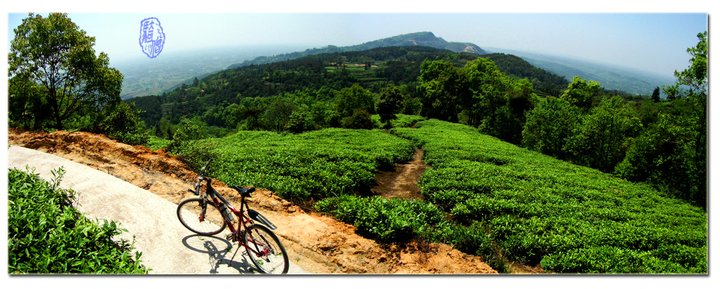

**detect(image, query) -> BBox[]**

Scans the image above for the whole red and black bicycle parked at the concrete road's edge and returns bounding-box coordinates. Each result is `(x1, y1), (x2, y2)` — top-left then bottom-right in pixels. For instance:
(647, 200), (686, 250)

(177, 161), (290, 274)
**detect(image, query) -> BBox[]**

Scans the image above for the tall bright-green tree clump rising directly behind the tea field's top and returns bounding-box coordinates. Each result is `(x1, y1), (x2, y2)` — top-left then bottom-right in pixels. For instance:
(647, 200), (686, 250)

(418, 58), (533, 143)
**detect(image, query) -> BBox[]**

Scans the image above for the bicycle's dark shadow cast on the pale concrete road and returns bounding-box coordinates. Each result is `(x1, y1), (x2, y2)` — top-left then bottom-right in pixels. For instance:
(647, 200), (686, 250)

(182, 234), (258, 274)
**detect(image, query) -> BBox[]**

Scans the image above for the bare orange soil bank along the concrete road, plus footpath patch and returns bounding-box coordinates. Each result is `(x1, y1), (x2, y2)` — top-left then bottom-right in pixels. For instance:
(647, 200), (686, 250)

(8, 129), (497, 274)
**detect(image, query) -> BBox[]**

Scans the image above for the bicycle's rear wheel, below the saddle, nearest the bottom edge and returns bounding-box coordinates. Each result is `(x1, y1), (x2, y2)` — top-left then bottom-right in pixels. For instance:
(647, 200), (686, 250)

(245, 224), (290, 274)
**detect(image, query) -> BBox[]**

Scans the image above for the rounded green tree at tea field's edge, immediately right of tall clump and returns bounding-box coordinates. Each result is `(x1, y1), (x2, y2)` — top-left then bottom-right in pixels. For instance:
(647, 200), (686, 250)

(522, 97), (580, 159)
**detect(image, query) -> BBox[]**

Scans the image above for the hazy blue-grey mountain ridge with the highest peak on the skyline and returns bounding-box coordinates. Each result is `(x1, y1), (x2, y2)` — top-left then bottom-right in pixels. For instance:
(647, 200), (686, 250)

(228, 32), (487, 69)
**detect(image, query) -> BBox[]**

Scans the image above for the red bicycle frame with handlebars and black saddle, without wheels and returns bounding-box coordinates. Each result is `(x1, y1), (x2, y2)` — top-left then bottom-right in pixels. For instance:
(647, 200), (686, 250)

(196, 176), (270, 257)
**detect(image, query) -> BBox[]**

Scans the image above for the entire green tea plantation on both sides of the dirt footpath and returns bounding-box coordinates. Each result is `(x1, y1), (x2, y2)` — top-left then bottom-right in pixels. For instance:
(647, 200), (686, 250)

(183, 120), (708, 274)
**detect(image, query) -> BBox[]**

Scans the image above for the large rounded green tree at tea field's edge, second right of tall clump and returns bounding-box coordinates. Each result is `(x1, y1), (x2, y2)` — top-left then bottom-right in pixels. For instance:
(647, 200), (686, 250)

(564, 96), (642, 172)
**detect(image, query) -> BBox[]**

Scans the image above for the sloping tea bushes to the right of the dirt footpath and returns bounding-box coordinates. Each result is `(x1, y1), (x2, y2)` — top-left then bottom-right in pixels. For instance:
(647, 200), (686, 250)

(394, 120), (708, 273)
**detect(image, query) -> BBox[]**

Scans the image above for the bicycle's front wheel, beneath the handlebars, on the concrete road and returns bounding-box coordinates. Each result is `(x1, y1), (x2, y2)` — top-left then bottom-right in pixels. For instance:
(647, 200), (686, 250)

(177, 198), (227, 236)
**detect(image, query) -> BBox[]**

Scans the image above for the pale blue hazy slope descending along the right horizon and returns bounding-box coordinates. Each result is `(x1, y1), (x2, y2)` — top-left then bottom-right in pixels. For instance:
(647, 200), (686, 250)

(488, 48), (675, 95)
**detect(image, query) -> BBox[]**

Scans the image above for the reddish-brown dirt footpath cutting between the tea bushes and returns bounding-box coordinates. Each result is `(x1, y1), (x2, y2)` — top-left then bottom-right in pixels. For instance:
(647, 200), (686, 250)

(370, 149), (426, 199)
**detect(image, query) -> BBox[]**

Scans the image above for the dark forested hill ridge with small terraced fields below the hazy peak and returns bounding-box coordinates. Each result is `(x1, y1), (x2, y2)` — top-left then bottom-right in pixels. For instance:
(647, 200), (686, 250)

(128, 46), (568, 128)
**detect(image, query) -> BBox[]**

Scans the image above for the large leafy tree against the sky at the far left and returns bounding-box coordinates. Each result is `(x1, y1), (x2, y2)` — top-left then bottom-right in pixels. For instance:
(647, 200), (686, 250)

(8, 13), (123, 129)
